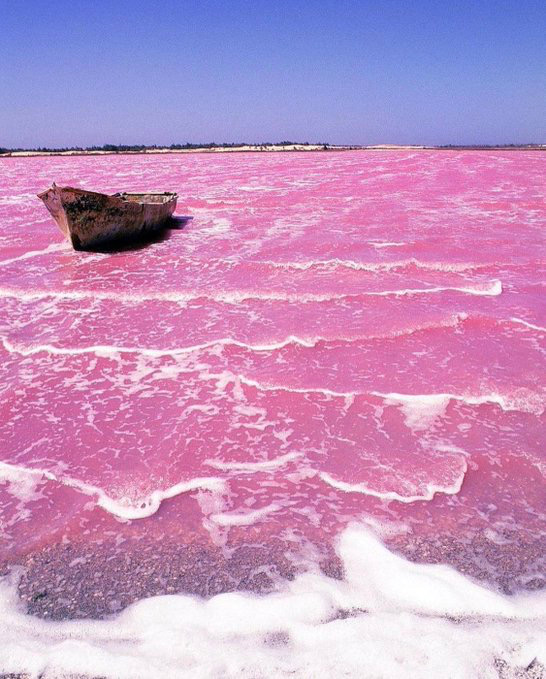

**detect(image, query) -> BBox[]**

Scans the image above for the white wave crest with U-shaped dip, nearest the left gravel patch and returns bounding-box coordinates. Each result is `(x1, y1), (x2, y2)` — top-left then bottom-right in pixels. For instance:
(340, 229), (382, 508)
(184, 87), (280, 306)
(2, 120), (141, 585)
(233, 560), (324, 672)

(0, 461), (226, 520)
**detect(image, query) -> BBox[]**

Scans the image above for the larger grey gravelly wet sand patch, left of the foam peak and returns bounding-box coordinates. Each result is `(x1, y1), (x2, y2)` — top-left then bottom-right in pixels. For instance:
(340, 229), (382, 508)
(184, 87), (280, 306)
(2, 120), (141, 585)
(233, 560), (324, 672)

(4, 541), (343, 620)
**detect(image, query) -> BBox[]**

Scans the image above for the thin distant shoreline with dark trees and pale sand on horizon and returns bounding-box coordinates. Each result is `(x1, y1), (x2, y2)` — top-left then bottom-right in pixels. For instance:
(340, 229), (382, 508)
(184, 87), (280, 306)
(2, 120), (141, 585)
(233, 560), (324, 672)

(0, 143), (546, 158)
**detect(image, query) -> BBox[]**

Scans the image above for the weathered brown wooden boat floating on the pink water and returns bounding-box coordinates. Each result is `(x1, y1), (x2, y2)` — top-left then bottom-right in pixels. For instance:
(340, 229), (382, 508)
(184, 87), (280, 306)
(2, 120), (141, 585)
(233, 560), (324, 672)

(38, 184), (178, 250)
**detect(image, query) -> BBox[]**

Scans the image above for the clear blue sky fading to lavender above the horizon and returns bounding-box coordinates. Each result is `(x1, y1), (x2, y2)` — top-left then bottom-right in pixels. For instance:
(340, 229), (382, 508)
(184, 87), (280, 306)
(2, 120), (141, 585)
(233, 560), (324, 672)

(0, 0), (546, 147)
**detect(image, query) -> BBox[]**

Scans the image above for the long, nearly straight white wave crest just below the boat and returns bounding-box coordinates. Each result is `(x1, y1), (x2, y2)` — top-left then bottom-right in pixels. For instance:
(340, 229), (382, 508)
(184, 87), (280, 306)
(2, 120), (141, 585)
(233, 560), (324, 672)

(0, 279), (502, 304)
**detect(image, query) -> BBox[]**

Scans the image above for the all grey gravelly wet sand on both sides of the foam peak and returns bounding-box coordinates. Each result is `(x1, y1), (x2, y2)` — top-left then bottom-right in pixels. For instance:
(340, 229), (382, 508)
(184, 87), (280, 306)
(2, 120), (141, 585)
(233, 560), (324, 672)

(0, 535), (546, 620)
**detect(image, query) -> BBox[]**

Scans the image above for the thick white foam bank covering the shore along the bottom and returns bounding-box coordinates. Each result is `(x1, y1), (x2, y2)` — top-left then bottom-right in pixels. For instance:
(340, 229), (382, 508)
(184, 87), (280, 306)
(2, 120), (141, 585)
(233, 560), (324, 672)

(0, 526), (546, 679)
